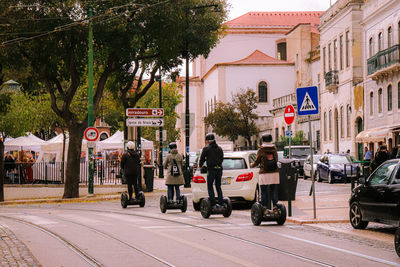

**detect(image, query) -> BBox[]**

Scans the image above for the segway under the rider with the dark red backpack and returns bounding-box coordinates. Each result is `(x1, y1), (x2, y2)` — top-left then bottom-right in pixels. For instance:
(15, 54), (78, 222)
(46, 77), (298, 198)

(251, 186), (286, 226)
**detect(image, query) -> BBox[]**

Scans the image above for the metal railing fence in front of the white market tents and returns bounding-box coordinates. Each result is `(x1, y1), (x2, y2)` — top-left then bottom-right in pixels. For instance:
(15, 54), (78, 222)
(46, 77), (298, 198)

(4, 160), (121, 184)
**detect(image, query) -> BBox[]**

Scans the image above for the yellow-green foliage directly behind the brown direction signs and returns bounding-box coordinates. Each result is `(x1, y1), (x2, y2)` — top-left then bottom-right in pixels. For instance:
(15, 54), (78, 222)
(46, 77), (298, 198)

(138, 83), (183, 142)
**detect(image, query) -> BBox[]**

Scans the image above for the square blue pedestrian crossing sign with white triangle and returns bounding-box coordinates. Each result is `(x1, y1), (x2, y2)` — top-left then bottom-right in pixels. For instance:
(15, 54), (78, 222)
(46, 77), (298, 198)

(296, 86), (319, 116)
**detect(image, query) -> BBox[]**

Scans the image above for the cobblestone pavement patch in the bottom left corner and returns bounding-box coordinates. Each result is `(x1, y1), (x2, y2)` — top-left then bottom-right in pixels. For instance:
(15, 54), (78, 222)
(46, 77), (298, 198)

(0, 224), (41, 267)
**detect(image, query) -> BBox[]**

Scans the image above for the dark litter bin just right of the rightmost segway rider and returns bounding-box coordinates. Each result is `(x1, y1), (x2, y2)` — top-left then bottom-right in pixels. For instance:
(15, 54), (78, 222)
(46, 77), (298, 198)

(278, 159), (298, 201)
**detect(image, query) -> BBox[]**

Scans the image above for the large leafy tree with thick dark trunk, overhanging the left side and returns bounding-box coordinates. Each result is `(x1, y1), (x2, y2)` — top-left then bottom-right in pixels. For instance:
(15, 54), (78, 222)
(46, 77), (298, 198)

(0, 0), (225, 198)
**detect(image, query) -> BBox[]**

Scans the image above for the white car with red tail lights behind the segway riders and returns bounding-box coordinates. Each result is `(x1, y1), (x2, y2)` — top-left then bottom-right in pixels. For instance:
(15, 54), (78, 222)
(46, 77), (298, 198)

(192, 151), (259, 210)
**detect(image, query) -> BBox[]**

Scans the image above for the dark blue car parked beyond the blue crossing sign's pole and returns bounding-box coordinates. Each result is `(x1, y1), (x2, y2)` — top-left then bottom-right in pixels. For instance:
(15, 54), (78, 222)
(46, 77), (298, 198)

(316, 154), (360, 184)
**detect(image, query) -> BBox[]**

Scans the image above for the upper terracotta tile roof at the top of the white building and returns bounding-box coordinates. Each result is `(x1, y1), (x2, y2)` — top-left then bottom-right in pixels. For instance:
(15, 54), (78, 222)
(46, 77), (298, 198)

(225, 11), (324, 28)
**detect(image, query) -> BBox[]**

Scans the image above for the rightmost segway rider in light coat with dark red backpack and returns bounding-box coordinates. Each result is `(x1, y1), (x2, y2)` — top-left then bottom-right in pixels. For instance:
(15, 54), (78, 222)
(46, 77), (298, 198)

(251, 134), (279, 212)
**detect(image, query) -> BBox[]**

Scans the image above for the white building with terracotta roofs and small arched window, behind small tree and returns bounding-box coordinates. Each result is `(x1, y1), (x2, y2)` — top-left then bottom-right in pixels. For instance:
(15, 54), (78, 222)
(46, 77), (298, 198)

(178, 12), (322, 151)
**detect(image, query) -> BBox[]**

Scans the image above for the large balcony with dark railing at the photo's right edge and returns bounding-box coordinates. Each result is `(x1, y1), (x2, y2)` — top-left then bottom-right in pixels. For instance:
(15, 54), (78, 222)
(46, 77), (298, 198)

(367, 44), (400, 83)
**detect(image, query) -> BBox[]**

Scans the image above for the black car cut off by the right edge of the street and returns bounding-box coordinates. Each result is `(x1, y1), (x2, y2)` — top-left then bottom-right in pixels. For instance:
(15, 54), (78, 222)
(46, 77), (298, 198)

(349, 159), (400, 256)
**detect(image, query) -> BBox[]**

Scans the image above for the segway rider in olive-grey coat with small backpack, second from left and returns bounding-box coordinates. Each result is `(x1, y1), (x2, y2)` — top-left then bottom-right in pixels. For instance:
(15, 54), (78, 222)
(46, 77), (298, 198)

(164, 143), (185, 202)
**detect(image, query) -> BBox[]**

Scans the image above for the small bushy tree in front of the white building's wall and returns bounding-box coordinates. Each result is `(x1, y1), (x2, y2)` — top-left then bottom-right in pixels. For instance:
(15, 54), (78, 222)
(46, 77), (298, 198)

(204, 89), (259, 143)
